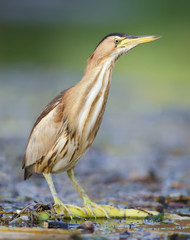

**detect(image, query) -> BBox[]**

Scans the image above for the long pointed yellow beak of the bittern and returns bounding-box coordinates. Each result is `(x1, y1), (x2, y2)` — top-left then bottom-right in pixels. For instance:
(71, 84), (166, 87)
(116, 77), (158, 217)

(119, 35), (161, 47)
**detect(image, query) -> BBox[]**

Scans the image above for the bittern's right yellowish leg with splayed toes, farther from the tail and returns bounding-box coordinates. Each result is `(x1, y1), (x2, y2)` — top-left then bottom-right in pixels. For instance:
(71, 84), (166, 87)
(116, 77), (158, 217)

(67, 169), (110, 218)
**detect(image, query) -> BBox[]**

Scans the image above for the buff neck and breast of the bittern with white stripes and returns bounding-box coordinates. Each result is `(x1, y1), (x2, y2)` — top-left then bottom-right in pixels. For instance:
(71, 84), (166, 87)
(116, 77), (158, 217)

(67, 56), (114, 139)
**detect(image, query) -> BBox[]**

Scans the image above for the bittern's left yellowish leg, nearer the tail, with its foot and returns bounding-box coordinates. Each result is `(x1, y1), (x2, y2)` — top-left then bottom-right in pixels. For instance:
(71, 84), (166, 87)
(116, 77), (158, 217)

(43, 173), (71, 214)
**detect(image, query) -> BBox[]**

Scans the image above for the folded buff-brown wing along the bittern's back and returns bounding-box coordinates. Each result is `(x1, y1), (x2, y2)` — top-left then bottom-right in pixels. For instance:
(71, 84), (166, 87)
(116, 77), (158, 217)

(22, 92), (64, 179)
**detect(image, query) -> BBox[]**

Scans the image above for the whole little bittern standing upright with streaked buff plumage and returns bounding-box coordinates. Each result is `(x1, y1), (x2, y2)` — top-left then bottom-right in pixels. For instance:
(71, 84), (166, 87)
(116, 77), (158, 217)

(22, 33), (159, 217)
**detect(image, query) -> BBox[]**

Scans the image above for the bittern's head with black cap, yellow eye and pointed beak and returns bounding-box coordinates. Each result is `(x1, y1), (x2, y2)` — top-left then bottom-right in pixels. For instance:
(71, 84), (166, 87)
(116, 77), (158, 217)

(94, 33), (160, 64)
